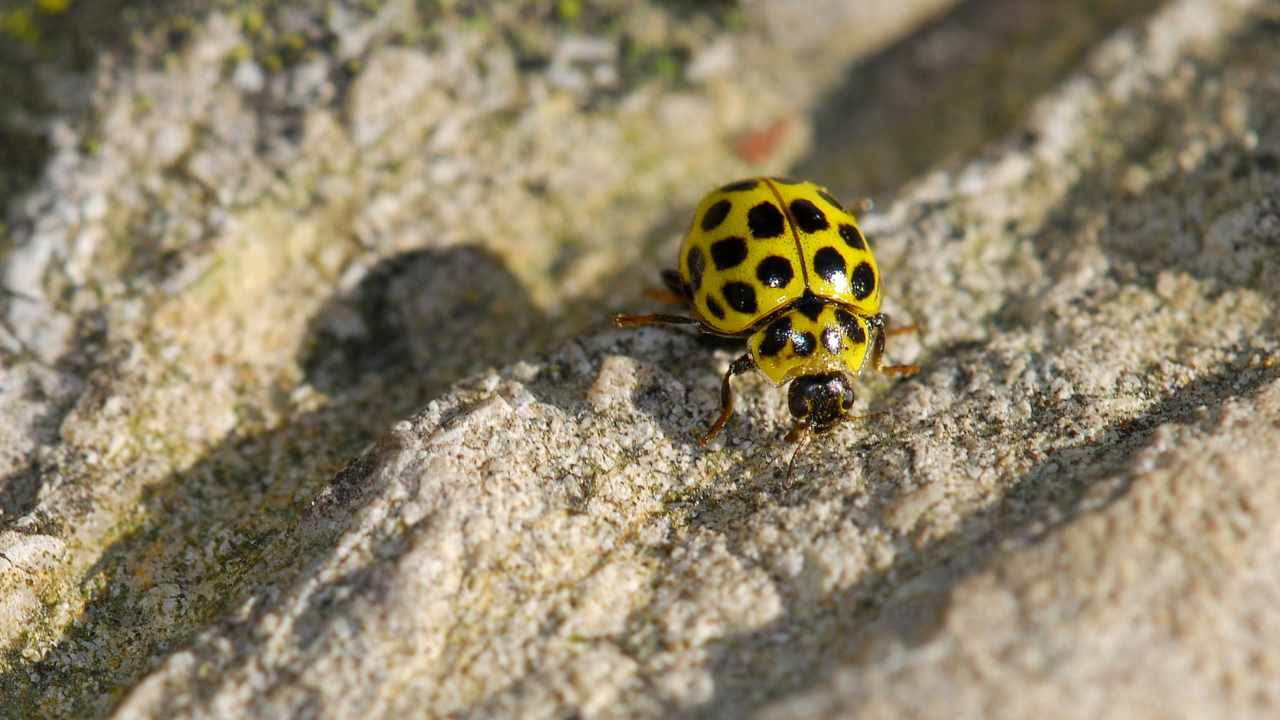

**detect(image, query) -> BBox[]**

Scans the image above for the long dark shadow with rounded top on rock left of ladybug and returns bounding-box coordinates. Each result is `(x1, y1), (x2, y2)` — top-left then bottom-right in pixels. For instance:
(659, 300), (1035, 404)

(0, 246), (543, 702)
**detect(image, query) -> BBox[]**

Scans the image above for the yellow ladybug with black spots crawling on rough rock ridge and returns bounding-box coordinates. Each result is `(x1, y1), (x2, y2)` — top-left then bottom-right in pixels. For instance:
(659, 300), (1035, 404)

(613, 177), (919, 452)
